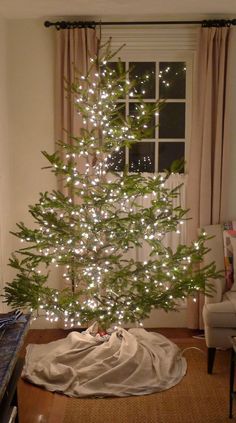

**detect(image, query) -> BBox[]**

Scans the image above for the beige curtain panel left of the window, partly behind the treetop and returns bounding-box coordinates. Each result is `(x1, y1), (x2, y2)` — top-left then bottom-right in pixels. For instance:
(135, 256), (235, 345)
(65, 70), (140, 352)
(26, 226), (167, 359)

(55, 28), (98, 189)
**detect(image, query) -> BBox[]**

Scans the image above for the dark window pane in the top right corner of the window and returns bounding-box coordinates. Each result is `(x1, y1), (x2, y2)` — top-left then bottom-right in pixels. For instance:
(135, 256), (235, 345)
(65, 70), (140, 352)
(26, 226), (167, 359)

(159, 62), (186, 98)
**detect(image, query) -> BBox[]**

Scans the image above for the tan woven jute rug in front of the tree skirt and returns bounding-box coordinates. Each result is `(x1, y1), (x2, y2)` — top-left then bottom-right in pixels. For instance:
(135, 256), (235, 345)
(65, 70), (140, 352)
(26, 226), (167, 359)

(58, 340), (231, 423)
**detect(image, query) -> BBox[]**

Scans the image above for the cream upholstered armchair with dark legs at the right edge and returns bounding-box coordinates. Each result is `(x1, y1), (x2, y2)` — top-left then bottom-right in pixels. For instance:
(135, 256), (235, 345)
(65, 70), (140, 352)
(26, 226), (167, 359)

(203, 225), (236, 373)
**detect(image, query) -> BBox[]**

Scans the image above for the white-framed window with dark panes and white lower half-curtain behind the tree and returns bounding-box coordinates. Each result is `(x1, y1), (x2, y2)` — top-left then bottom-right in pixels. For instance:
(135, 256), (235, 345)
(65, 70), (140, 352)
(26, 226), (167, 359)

(102, 25), (197, 314)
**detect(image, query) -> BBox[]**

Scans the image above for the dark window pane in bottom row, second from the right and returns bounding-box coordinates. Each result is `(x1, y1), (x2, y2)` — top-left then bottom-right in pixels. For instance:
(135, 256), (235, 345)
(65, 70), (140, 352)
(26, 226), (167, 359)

(129, 141), (155, 172)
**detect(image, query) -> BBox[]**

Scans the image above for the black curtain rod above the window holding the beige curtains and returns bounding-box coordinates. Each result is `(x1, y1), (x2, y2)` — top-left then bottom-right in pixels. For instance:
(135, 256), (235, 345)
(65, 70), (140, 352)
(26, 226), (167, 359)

(44, 19), (236, 30)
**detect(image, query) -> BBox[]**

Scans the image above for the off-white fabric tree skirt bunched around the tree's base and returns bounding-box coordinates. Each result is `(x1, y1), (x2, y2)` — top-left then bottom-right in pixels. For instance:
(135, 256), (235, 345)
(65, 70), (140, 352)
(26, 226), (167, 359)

(22, 328), (187, 397)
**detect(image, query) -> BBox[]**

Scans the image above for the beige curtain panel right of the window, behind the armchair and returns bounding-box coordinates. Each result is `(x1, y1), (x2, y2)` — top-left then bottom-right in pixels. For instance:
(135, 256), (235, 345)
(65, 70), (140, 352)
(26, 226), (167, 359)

(187, 27), (231, 328)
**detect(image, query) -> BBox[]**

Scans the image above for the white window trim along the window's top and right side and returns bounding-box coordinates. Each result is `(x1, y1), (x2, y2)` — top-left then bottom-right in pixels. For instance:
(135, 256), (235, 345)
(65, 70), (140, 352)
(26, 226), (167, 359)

(98, 24), (198, 310)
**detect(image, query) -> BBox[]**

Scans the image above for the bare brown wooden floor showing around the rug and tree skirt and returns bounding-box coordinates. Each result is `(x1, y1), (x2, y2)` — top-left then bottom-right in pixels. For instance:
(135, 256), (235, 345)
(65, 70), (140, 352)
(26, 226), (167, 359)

(18, 328), (202, 423)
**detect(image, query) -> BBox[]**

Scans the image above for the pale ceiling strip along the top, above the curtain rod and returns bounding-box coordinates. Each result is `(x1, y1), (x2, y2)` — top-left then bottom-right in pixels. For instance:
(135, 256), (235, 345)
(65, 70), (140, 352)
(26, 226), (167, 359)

(0, 0), (236, 20)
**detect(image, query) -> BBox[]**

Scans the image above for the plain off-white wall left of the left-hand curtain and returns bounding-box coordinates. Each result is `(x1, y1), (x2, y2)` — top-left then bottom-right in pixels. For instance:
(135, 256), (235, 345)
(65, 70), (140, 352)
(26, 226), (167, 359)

(0, 20), (57, 326)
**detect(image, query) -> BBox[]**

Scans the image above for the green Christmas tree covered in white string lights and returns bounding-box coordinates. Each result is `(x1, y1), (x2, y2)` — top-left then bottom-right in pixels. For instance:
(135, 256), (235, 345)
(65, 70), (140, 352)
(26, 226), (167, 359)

(5, 39), (218, 328)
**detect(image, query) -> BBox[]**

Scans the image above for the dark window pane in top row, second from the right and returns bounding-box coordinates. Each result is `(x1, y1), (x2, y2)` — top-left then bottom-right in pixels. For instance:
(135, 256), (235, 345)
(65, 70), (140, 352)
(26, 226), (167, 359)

(129, 62), (156, 98)
